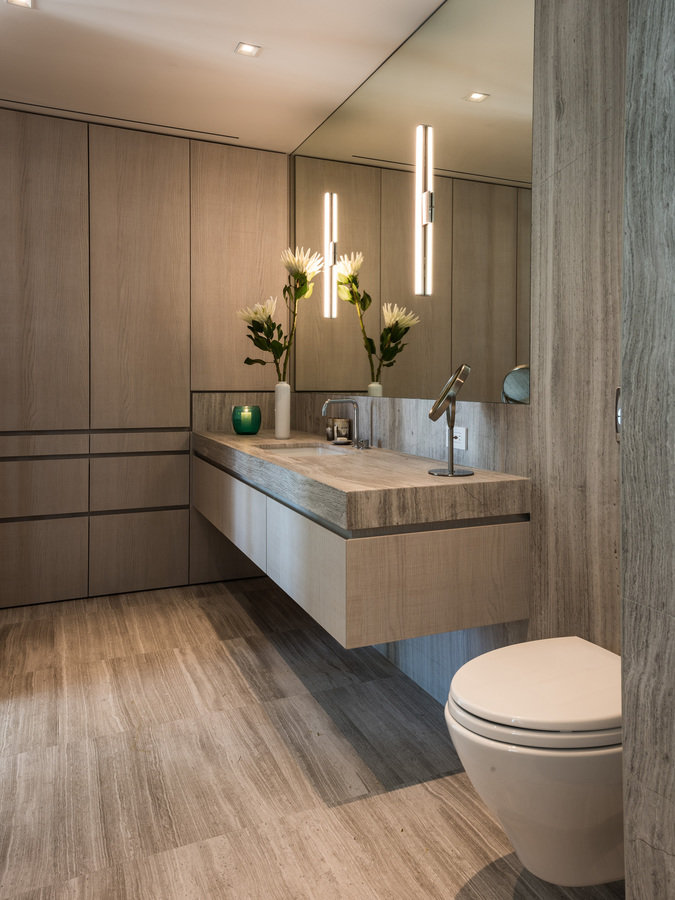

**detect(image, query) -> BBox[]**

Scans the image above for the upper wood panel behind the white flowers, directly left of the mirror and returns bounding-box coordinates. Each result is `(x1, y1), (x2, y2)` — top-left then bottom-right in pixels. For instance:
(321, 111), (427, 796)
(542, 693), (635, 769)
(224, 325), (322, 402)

(191, 141), (288, 391)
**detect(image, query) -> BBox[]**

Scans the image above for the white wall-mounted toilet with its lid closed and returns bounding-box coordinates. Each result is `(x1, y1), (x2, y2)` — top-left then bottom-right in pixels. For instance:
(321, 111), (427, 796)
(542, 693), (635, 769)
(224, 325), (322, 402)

(445, 637), (623, 886)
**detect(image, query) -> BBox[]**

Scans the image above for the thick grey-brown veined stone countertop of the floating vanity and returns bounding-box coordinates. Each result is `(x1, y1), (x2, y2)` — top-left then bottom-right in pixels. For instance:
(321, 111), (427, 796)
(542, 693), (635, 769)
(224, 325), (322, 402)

(192, 431), (530, 533)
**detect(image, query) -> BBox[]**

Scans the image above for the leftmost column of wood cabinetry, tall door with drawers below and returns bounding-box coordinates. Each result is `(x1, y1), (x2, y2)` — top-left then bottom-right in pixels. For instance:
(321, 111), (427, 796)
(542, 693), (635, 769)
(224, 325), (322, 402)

(0, 109), (89, 606)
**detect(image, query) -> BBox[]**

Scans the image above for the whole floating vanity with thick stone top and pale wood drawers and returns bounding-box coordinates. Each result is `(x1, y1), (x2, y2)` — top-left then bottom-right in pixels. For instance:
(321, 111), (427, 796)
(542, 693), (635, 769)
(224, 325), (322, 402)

(192, 434), (530, 647)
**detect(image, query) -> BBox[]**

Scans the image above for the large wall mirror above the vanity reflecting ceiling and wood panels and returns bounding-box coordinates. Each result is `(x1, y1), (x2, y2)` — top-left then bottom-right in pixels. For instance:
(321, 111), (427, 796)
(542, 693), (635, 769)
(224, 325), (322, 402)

(292, 0), (534, 402)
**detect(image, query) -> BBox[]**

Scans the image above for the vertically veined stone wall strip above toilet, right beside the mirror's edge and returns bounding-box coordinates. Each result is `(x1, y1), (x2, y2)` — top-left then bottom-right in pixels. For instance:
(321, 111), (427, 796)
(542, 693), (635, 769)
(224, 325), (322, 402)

(531, 0), (626, 652)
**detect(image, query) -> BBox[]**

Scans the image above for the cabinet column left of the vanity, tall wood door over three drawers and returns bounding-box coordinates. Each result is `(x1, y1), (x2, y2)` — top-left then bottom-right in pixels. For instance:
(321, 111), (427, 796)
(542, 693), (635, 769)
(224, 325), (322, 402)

(89, 125), (190, 594)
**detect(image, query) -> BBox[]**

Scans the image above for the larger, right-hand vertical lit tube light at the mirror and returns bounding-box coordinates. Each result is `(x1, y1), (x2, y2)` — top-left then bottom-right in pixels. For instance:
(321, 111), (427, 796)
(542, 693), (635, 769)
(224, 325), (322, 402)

(415, 125), (434, 297)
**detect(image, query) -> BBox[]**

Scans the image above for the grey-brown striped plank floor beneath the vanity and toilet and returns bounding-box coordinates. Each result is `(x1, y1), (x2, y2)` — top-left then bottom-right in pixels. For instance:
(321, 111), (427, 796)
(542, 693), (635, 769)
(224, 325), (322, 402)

(0, 578), (623, 900)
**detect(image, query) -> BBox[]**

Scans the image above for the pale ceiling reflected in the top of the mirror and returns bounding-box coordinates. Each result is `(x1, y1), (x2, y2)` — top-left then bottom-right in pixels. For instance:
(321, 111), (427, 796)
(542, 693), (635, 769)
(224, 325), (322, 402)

(298, 0), (534, 183)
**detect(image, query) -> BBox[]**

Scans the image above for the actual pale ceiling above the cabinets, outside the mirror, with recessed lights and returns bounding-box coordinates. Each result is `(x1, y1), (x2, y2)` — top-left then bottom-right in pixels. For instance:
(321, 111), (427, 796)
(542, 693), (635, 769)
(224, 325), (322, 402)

(0, 0), (439, 152)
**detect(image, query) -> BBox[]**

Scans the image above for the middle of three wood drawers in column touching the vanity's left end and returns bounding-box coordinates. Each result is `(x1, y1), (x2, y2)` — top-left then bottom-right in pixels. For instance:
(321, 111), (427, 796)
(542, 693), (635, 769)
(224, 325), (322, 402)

(89, 454), (190, 511)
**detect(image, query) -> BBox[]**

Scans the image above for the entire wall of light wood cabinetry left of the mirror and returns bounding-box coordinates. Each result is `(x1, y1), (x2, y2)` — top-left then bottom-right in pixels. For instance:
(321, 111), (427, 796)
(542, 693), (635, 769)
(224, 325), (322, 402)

(0, 109), (288, 606)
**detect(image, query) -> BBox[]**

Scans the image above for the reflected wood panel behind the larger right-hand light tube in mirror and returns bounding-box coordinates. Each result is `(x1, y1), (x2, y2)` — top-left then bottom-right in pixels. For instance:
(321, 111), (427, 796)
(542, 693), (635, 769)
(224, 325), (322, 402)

(376, 169), (453, 397)
